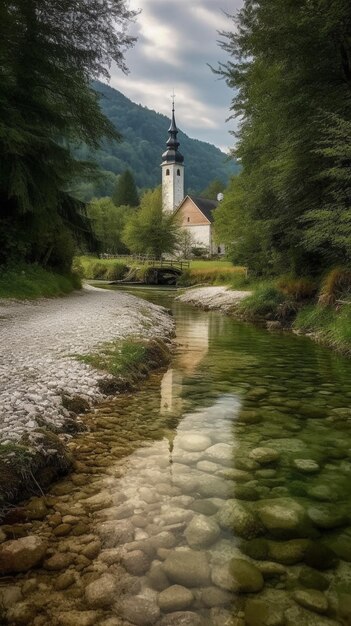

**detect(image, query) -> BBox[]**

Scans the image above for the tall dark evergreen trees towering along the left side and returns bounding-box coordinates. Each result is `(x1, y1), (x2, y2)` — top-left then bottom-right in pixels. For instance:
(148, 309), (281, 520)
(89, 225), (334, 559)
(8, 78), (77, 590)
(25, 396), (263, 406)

(0, 0), (133, 270)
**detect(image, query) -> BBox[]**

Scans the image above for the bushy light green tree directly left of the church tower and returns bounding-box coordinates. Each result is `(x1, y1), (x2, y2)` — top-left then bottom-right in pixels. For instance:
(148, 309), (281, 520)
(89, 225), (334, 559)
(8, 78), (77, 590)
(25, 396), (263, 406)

(123, 187), (179, 259)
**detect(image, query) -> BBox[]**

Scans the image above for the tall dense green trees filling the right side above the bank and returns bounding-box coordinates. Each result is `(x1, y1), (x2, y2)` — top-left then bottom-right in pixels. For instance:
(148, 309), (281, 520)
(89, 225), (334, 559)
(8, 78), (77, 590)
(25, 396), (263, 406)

(216, 0), (351, 274)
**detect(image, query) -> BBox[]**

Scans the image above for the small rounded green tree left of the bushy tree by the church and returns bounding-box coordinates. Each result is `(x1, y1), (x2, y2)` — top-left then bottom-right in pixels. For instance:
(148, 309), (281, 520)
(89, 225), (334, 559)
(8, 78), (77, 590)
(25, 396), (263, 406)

(87, 198), (135, 254)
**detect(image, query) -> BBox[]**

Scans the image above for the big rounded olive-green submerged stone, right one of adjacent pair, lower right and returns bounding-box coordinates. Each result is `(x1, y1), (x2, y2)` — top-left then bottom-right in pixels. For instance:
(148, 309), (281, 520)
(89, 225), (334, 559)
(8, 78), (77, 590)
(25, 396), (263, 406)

(256, 498), (305, 534)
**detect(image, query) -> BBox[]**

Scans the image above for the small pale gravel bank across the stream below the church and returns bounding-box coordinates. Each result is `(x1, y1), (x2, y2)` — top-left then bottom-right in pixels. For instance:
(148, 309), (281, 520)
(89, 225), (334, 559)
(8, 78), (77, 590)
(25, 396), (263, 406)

(177, 286), (250, 313)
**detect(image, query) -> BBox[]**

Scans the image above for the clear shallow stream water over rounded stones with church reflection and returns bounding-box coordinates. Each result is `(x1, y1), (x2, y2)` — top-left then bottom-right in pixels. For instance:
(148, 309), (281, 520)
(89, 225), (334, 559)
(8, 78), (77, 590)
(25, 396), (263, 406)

(0, 289), (351, 626)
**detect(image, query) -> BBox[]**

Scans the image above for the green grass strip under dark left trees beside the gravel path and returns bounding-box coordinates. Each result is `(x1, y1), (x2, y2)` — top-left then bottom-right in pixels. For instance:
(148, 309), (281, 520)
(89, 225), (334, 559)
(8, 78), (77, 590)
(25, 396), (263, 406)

(0, 264), (81, 300)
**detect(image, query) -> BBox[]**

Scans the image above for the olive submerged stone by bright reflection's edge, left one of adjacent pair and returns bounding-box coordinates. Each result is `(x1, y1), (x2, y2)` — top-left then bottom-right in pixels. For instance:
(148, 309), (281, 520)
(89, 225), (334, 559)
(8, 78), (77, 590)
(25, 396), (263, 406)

(217, 500), (263, 539)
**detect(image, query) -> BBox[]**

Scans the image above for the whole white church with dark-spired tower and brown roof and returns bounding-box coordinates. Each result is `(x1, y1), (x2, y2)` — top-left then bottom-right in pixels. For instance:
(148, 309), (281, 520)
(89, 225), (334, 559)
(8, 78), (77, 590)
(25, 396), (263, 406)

(161, 101), (224, 256)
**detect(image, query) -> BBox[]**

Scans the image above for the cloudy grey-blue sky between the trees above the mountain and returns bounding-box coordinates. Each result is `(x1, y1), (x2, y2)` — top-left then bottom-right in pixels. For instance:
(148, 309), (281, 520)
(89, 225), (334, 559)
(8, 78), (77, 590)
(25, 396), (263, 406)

(110, 0), (242, 152)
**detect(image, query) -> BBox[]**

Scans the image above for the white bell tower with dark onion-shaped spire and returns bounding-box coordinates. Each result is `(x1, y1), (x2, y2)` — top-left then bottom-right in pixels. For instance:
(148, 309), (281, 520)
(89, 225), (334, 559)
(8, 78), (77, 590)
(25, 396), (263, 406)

(161, 96), (184, 213)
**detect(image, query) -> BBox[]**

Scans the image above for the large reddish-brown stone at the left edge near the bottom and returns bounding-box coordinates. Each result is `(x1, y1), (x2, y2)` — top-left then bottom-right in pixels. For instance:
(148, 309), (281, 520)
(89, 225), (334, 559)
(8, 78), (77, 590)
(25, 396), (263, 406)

(0, 535), (47, 574)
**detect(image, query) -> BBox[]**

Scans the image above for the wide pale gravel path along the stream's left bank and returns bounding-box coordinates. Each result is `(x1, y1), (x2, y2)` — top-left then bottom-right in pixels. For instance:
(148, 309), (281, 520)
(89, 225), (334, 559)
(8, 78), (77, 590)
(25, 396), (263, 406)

(0, 287), (173, 443)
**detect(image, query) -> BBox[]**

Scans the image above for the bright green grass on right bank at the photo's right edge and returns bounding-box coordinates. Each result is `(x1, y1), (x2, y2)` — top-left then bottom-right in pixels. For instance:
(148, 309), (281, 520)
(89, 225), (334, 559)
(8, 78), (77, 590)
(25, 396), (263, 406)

(293, 304), (351, 356)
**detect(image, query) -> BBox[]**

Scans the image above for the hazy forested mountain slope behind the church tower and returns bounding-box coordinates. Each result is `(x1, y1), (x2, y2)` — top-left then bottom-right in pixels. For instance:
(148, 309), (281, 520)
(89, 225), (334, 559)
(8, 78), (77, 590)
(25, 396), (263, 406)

(78, 82), (238, 200)
